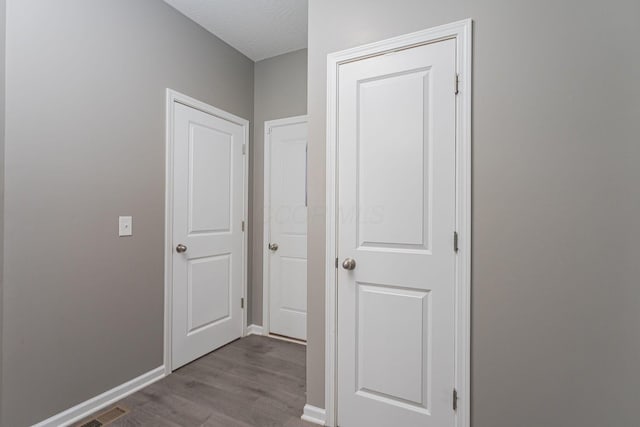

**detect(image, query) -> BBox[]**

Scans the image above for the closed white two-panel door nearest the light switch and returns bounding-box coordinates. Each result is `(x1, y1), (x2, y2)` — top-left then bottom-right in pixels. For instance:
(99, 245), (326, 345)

(172, 103), (245, 369)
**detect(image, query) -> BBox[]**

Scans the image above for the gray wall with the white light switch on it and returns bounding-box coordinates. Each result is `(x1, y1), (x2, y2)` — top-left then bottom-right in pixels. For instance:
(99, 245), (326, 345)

(2, 0), (253, 427)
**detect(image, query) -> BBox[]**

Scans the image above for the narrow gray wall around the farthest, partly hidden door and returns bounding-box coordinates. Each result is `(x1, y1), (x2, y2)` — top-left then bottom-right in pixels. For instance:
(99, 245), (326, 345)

(249, 49), (307, 325)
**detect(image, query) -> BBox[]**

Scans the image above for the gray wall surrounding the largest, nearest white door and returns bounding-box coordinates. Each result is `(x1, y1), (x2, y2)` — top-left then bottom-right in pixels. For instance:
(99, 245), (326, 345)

(307, 0), (640, 427)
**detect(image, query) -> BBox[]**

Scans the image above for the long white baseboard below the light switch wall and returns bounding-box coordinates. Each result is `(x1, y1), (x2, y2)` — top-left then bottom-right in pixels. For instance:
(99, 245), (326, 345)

(32, 366), (165, 427)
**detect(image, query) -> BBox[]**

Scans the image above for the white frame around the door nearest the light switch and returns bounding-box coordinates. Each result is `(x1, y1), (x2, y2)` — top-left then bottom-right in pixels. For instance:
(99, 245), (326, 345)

(164, 89), (250, 375)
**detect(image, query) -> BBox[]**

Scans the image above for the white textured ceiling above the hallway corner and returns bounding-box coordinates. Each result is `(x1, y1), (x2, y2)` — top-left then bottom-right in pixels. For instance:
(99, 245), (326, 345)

(164, 0), (307, 61)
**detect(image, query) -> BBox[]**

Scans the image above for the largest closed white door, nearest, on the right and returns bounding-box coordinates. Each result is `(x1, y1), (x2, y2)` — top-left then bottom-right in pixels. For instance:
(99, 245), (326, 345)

(337, 40), (456, 427)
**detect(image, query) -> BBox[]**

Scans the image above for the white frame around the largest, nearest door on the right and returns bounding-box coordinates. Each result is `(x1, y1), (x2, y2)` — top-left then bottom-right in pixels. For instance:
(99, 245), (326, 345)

(325, 19), (472, 427)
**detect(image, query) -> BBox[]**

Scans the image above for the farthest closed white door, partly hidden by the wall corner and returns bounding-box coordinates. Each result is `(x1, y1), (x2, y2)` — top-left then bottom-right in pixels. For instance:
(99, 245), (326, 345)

(265, 118), (307, 340)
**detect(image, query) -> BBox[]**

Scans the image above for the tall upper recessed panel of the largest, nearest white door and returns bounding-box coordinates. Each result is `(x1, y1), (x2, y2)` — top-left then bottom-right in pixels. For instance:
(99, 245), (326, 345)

(356, 69), (430, 249)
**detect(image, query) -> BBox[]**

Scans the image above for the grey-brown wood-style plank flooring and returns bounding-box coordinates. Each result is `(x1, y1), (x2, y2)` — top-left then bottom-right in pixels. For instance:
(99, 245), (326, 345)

(81, 335), (315, 427)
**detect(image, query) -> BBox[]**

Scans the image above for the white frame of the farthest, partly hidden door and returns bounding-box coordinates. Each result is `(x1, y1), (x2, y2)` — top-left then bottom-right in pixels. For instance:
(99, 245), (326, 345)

(262, 115), (309, 342)
